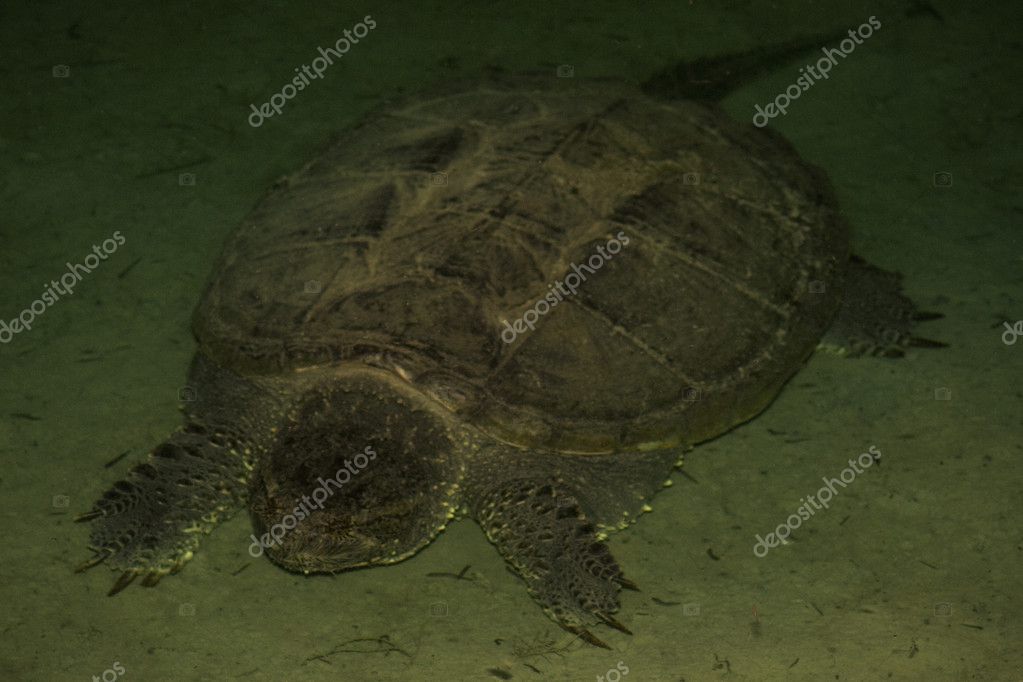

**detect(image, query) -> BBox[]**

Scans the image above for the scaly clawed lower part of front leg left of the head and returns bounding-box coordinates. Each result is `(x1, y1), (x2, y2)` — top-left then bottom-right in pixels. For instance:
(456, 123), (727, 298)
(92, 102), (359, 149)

(76, 423), (248, 595)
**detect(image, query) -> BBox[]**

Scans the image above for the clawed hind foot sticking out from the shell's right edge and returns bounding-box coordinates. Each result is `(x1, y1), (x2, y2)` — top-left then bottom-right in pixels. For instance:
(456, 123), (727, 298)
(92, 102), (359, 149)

(819, 256), (946, 358)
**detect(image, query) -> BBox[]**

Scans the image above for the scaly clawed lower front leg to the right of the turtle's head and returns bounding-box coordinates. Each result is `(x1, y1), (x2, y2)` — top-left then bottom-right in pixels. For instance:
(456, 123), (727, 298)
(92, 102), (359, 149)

(471, 479), (635, 648)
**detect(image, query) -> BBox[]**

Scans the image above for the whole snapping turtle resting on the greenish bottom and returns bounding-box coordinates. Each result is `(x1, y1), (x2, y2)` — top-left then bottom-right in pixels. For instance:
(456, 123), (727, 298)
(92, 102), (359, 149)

(80, 36), (934, 645)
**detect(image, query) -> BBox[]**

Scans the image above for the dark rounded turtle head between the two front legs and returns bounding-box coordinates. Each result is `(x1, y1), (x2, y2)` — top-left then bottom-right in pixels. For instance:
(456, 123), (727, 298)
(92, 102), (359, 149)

(249, 372), (458, 573)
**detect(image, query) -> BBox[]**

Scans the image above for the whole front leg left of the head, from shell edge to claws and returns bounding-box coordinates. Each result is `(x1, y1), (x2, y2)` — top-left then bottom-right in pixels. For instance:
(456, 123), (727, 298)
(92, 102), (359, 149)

(76, 354), (279, 595)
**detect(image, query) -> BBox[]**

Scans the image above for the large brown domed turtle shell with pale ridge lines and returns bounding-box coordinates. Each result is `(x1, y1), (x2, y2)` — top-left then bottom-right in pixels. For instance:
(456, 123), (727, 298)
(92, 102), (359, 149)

(194, 79), (848, 453)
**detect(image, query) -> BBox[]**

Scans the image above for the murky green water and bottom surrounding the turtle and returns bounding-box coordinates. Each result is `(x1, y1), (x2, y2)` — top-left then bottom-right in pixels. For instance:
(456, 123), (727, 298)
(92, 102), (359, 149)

(0, 0), (1023, 682)
